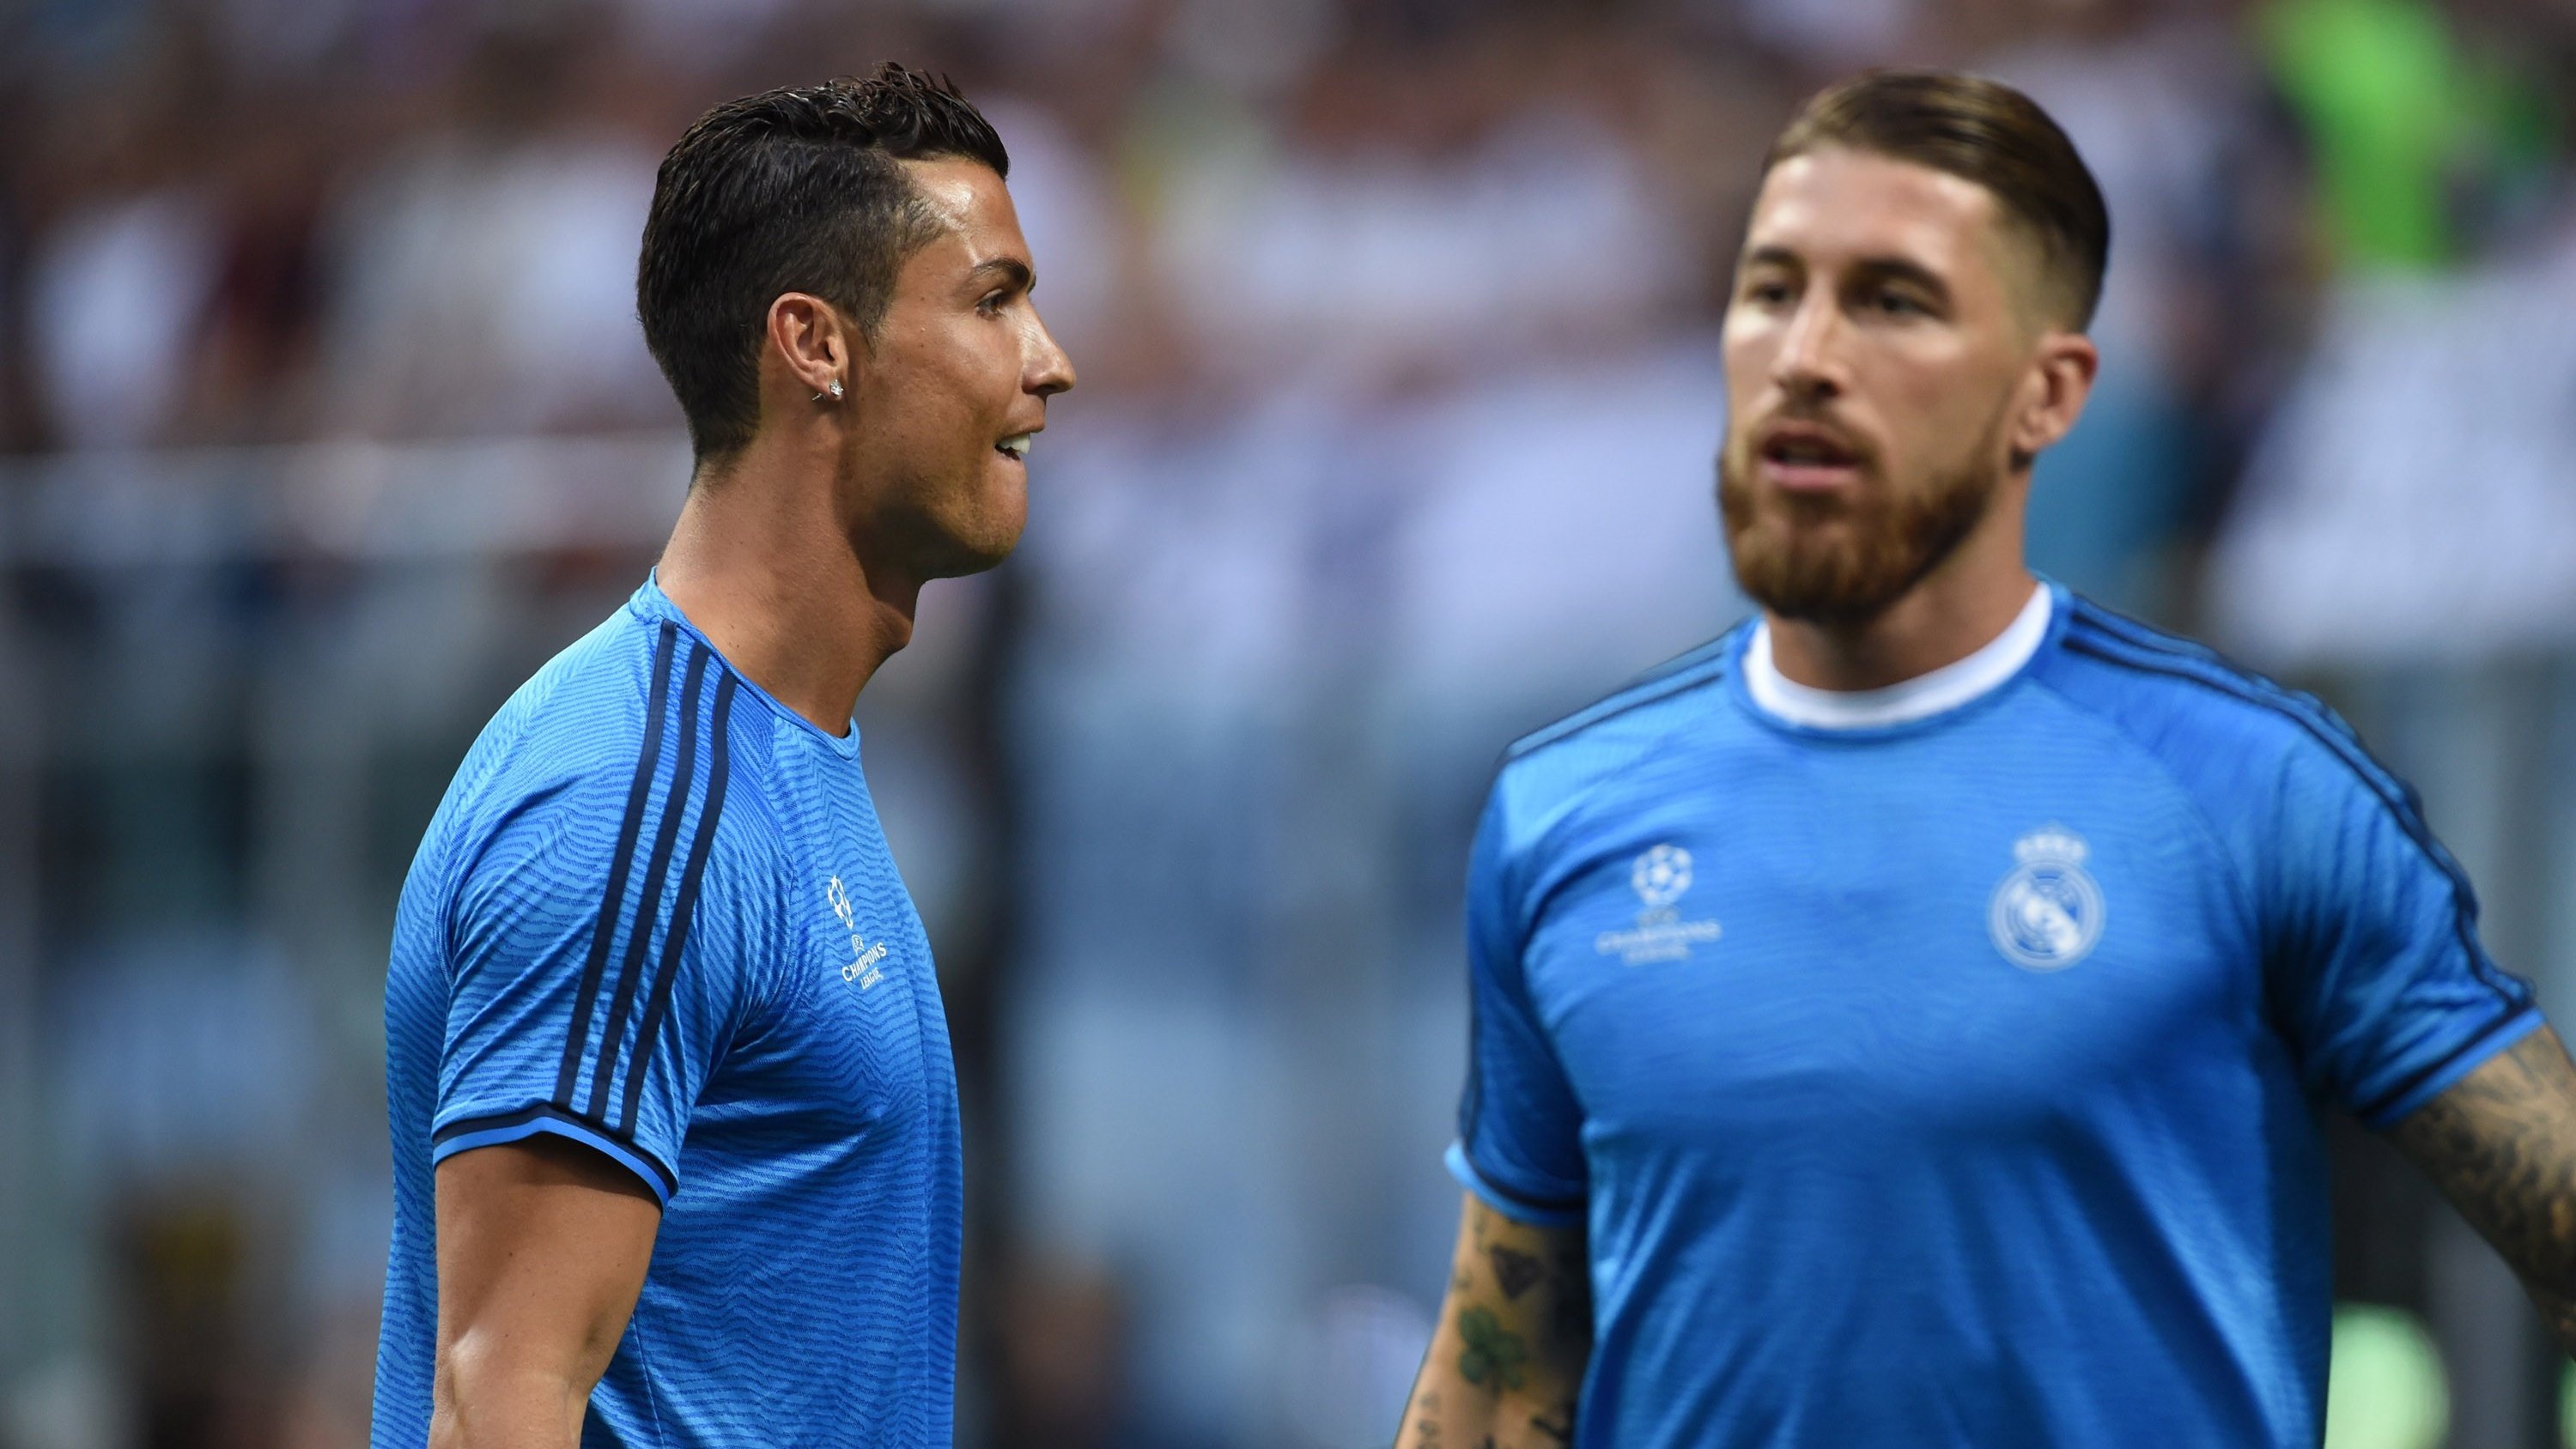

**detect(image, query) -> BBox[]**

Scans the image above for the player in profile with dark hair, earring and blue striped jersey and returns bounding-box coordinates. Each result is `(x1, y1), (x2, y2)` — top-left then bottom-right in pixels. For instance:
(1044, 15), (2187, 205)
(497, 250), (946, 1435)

(374, 64), (1074, 1449)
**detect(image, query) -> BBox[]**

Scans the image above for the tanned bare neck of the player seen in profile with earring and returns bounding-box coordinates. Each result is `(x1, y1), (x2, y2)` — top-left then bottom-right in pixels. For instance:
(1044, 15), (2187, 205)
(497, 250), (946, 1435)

(657, 427), (922, 736)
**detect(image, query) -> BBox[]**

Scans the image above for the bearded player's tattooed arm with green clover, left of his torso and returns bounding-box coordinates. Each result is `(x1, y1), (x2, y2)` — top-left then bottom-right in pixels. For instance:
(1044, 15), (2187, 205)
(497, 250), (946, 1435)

(1396, 1194), (1592, 1449)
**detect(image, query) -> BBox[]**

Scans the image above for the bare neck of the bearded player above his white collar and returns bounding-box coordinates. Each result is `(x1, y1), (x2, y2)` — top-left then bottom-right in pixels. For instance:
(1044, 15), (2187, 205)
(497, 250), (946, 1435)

(1765, 497), (2038, 690)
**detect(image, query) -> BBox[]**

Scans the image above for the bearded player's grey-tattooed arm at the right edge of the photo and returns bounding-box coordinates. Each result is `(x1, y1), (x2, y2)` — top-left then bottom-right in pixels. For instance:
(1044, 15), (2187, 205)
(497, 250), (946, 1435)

(2388, 1027), (2576, 1354)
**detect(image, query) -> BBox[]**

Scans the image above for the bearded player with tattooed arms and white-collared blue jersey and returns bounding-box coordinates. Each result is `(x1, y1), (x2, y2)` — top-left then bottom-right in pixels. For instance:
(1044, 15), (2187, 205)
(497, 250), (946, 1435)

(1399, 72), (2576, 1449)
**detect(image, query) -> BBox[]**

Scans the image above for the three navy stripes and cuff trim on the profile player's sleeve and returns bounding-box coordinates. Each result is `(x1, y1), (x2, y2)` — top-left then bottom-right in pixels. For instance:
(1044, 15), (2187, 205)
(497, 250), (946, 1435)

(438, 623), (734, 1199)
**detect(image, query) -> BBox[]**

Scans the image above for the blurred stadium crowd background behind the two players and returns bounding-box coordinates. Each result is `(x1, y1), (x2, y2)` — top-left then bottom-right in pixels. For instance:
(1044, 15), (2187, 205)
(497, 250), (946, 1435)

(0, 0), (2576, 1449)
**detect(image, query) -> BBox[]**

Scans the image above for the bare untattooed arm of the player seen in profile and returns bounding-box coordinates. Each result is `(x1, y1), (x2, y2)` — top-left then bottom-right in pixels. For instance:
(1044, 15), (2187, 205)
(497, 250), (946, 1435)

(430, 1137), (662, 1449)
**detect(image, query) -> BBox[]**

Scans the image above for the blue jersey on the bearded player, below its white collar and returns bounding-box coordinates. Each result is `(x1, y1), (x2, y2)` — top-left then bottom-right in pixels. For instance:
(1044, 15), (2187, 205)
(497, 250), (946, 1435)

(1450, 592), (2540, 1449)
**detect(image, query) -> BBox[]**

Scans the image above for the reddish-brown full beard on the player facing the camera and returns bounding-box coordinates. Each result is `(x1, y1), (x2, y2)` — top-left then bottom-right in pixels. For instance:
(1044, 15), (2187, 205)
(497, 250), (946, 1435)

(1718, 417), (2004, 626)
